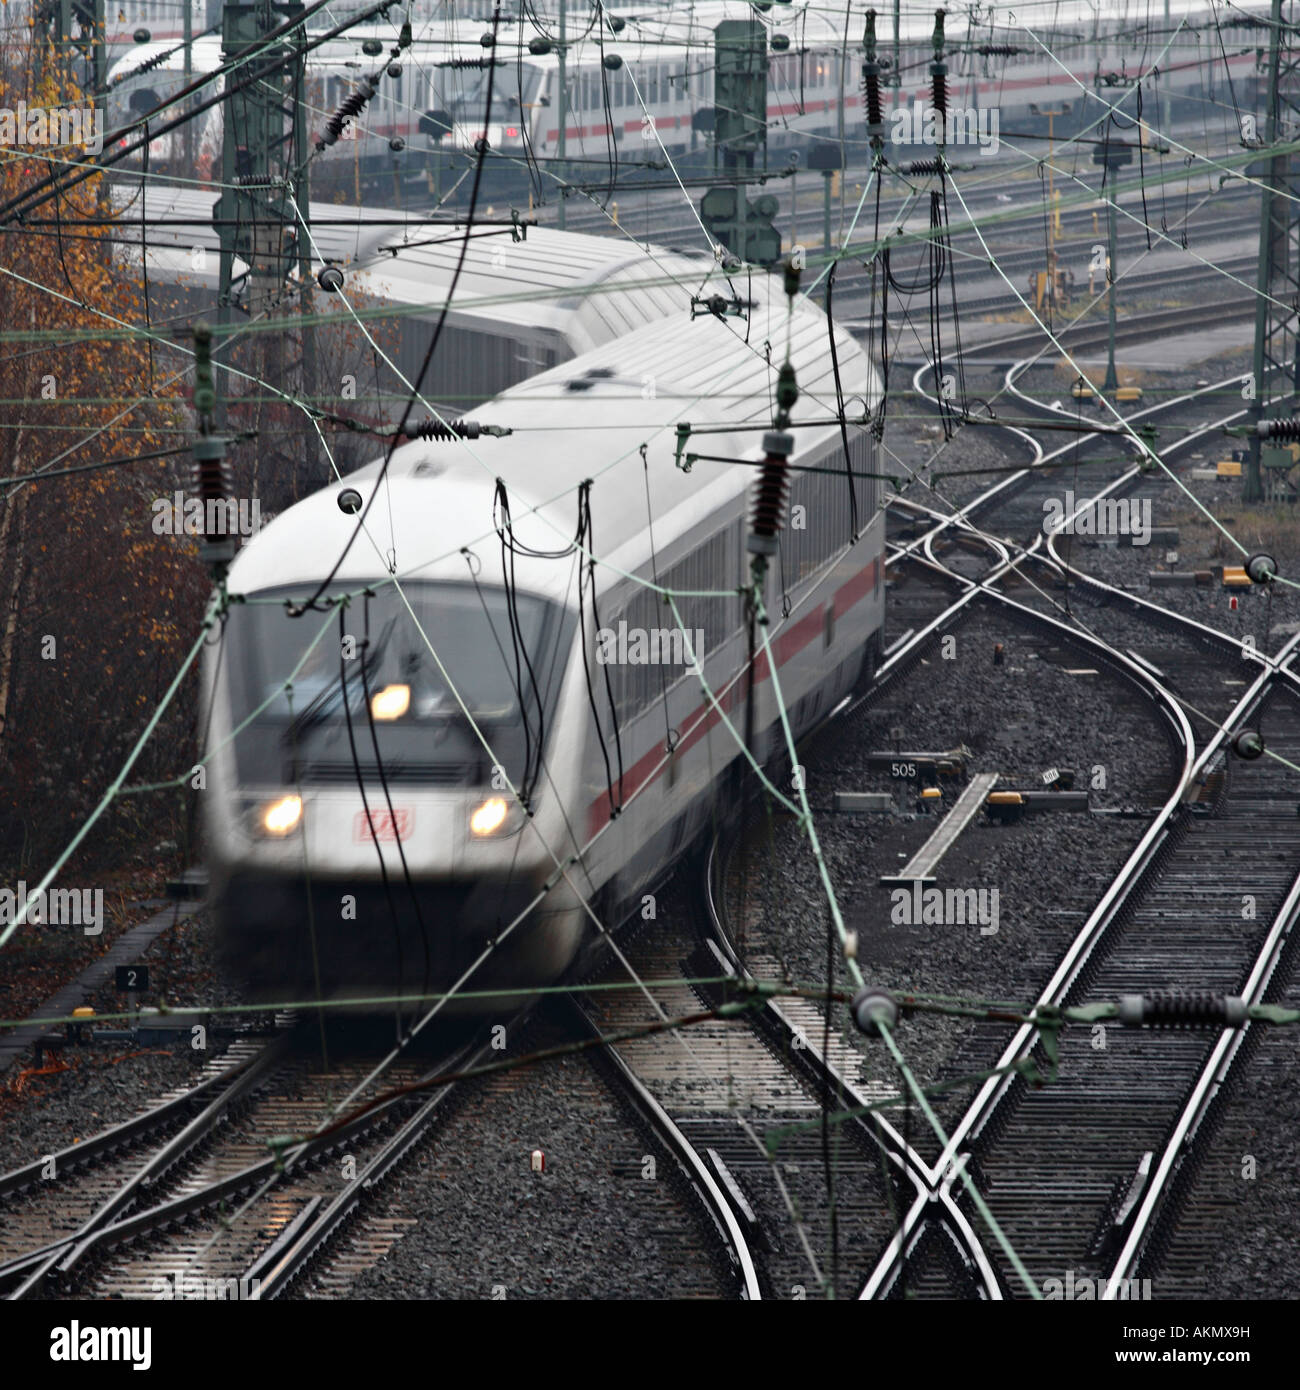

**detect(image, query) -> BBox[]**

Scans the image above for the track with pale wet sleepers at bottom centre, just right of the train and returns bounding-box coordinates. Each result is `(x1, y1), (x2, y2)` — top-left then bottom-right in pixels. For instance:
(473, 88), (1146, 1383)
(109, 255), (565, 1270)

(576, 872), (1001, 1298)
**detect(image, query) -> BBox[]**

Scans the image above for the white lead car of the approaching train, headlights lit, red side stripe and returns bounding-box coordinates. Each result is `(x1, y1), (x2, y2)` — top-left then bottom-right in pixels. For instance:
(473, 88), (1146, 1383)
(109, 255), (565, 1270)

(203, 263), (884, 1012)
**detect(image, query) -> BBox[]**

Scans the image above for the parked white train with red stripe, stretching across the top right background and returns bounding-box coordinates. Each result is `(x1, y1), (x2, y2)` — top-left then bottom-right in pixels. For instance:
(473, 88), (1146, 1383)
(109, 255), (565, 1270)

(478, 0), (1268, 163)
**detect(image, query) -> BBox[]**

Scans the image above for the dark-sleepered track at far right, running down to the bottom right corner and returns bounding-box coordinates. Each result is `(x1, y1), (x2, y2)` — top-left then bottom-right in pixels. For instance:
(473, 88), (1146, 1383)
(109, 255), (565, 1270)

(834, 344), (1300, 1297)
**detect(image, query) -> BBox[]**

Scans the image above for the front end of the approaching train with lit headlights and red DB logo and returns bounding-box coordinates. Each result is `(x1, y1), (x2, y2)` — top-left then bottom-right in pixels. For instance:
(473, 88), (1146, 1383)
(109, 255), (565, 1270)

(200, 492), (581, 1012)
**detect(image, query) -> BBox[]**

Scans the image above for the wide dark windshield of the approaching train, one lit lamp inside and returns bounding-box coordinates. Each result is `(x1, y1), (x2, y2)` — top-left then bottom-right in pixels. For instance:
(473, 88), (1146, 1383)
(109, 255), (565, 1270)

(222, 584), (564, 783)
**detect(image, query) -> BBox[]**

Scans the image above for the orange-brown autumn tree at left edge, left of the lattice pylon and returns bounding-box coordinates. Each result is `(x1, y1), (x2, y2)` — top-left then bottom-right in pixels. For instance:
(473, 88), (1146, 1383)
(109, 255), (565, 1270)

(0, 40), (210, 881)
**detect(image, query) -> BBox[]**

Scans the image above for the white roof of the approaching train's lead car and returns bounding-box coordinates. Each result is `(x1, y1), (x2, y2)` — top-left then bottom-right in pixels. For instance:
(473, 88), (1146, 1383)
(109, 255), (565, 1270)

(228, 286), (876, 605)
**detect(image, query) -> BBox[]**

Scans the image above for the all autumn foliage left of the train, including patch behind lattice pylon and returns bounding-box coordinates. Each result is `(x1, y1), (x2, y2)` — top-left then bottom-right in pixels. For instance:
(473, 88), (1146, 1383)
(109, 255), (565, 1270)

(0, 21), (411, 881)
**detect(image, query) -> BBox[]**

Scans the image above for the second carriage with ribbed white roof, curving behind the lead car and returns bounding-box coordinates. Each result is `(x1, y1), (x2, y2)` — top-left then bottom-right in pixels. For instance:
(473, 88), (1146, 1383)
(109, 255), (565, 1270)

(113, 178), (722, 408)
